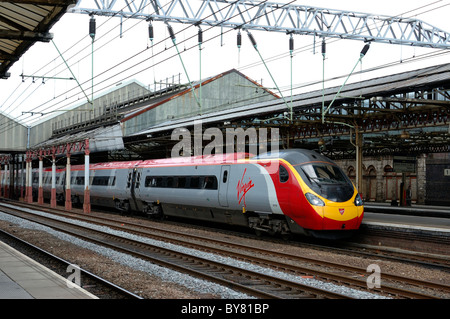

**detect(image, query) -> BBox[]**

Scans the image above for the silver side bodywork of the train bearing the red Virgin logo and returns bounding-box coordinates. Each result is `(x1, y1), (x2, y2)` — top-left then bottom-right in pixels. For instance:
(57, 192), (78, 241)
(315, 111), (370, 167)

(27, 162), (282, 225)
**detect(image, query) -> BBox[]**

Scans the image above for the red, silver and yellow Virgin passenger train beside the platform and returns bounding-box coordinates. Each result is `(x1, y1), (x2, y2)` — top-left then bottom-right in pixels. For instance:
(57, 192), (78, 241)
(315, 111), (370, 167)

(1, 149), (364, 239)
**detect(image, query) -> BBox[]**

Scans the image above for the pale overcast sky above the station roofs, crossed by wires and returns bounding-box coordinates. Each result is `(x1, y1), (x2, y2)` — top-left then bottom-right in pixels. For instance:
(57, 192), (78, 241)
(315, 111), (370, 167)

(0, 0), (450, 125)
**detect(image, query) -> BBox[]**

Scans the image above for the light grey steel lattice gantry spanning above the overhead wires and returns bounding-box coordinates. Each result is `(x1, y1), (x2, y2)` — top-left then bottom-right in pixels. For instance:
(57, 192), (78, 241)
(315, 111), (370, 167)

(68, 0), (450, 49)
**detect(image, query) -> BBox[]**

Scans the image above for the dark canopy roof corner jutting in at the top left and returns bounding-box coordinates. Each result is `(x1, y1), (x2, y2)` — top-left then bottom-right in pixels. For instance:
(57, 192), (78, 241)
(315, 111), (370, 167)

(0, 0), (76, 79)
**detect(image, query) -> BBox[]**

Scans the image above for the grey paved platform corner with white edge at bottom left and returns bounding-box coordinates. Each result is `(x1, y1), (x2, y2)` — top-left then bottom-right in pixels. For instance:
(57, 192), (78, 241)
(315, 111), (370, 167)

(0, 241), (98, 299)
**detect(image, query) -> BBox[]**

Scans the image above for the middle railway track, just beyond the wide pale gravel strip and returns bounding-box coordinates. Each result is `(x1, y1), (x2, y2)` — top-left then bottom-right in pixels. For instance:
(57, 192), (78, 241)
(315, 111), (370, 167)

(2, 202), (350, 299)
